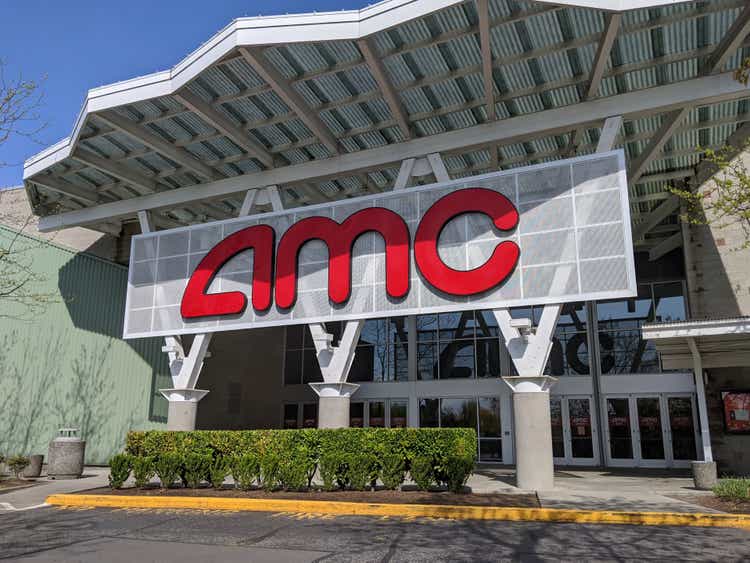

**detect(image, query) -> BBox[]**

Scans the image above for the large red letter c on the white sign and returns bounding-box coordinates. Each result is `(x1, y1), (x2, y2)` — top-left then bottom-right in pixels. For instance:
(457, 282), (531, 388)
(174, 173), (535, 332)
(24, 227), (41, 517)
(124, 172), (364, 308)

(414, 188), (520, 295)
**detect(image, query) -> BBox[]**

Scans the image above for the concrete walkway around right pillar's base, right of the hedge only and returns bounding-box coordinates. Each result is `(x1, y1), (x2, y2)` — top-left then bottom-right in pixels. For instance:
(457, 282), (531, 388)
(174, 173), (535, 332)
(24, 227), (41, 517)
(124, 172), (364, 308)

(467, 465), (713, 512)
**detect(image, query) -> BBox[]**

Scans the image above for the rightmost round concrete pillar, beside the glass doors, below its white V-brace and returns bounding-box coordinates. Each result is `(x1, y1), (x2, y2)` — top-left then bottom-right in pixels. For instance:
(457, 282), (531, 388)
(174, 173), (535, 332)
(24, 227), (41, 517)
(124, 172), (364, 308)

(503, 375), (557, 491)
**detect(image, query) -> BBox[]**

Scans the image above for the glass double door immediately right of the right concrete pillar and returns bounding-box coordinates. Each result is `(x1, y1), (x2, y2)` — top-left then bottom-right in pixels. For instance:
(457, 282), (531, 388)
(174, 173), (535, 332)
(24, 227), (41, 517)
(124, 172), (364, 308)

(550, 396), (599, 465)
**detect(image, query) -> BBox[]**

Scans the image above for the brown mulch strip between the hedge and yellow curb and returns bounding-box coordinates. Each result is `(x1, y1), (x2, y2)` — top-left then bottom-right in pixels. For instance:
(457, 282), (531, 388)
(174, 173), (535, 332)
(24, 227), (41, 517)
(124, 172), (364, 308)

(77, 487), (540, 508)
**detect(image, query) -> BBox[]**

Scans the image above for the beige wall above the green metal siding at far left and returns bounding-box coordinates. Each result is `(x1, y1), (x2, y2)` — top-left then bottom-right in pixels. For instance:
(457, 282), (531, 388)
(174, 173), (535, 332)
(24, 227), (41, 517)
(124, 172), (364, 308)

(0, 187), (118, 261)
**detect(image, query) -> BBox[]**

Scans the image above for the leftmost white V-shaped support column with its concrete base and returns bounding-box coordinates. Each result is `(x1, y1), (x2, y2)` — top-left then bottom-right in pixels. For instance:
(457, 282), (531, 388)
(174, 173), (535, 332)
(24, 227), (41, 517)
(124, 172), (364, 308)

(138, 211), (212, 430)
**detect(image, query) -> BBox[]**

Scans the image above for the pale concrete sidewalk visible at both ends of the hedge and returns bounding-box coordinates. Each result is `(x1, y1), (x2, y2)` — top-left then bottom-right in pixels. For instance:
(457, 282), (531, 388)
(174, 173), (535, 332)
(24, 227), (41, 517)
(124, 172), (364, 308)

(0, 465), (716, 513)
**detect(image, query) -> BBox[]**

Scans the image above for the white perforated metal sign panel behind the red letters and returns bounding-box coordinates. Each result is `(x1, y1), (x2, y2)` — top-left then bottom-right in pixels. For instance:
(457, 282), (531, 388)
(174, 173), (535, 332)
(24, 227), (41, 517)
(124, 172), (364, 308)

(124, 151), (636, 338)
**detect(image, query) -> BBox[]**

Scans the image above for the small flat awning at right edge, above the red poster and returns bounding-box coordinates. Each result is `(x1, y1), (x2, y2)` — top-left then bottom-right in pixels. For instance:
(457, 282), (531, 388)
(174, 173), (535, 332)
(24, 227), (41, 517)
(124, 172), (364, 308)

(641, 317), (750, 369)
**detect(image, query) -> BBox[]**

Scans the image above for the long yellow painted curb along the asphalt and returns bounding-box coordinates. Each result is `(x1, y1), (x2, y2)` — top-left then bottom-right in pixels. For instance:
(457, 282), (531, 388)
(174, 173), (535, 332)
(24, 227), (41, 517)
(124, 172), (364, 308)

(47, 495), (750, 530)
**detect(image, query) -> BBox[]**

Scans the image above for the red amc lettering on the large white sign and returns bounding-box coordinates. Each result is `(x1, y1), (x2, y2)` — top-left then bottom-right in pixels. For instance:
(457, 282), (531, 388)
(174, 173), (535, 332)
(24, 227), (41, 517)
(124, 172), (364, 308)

(180, 188), (520, 319)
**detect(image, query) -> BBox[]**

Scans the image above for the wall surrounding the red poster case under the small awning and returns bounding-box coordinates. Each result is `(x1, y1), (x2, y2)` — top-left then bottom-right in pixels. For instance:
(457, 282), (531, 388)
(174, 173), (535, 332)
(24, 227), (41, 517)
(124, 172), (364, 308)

(706, 367), (750, 476)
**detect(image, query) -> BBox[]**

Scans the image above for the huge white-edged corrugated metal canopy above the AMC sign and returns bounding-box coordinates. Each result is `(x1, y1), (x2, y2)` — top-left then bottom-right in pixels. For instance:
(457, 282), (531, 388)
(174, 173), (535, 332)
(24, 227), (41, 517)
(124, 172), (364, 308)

(24, 0), (750, 247)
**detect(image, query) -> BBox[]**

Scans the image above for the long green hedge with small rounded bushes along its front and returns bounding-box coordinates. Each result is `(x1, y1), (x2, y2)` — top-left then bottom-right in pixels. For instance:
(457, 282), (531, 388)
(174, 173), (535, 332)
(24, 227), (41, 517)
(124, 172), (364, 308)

(119, 428), (477, 491)
